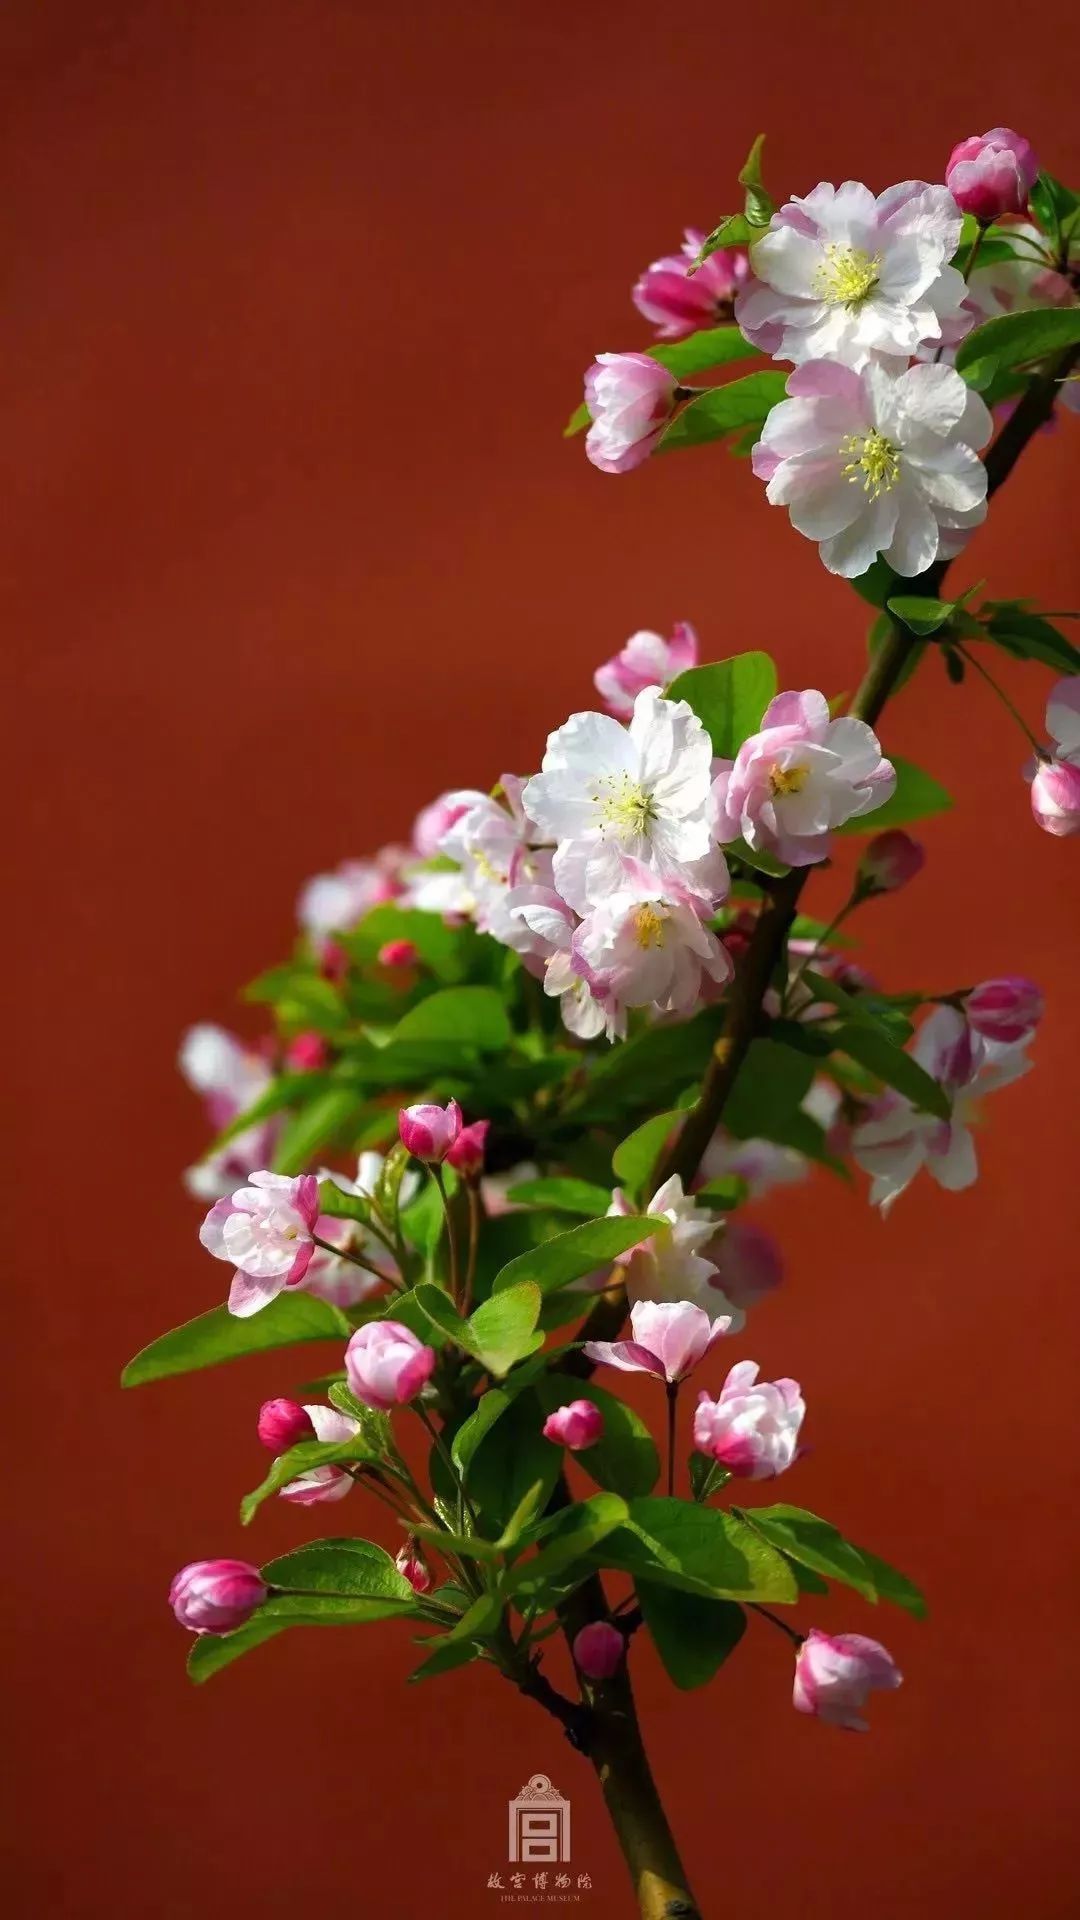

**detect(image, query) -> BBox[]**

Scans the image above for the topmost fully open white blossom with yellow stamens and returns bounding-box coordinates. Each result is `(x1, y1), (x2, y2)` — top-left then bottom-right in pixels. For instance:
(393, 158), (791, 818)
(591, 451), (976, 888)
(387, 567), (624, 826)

(734, 180), (965, 369)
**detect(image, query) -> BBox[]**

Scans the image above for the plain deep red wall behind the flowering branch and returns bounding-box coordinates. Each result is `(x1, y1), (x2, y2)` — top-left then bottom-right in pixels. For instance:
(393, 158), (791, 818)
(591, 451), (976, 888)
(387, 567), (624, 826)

(0, 0), (1080, 1920)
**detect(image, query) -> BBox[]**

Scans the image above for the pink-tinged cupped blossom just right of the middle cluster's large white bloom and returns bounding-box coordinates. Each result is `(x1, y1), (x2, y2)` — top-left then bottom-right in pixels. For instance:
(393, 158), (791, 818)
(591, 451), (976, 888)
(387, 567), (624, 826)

(713, 687), (896, 866)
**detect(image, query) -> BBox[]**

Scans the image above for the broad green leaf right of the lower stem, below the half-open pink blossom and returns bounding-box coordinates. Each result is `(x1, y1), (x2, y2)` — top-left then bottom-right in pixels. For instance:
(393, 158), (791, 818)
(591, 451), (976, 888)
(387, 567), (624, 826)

(596, 1496), (798, 1601)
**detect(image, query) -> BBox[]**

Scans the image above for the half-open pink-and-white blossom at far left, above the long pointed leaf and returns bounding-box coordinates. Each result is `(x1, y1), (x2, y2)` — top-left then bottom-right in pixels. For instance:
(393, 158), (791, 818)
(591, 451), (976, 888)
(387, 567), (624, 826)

(198, 1173), (319, 1319)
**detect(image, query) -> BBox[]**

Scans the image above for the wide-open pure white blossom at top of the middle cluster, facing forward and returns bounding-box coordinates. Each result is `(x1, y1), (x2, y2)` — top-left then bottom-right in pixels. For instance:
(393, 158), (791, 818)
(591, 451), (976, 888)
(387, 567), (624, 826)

(523, 687), (728, 914)
